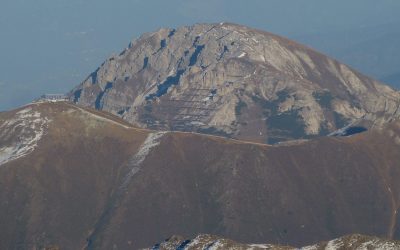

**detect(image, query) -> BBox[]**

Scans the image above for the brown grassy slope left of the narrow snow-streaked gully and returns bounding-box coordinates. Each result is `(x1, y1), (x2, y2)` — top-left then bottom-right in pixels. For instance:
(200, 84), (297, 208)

(0, 104), (147, 249)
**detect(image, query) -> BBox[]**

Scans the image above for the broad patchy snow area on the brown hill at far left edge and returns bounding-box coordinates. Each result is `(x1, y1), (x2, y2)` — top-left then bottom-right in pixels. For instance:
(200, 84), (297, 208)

(0, 107), (50, 165)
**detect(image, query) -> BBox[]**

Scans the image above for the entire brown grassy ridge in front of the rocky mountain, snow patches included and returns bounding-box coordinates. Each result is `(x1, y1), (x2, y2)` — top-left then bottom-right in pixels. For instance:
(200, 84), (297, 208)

(0, 103), (400, 249)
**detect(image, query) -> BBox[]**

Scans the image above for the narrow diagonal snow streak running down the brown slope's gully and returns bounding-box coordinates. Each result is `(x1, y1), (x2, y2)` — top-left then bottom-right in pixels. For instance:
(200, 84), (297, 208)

(121, 132), (167, 188)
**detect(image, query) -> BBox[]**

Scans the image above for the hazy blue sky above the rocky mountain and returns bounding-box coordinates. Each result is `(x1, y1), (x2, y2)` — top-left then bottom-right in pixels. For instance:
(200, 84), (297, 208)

(0, 0), (400, 110)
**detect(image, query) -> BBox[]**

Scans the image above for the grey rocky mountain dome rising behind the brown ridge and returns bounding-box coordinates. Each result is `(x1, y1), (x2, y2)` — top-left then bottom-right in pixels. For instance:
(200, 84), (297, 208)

(69, 23), (400, 143)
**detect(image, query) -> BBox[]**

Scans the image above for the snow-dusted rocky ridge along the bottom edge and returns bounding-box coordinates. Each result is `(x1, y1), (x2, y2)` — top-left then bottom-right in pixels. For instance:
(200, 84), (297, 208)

(145, 234), (400, 250)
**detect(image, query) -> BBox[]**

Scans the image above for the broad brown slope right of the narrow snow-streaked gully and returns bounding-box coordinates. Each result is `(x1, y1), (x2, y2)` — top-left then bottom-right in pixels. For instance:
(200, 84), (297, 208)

(92, 125), (400, 249)
